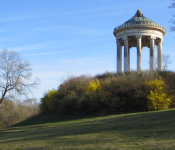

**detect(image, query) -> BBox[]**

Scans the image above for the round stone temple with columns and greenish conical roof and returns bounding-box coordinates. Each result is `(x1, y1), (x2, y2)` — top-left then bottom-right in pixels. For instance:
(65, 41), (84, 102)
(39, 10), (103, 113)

(113, 9), (166, 72)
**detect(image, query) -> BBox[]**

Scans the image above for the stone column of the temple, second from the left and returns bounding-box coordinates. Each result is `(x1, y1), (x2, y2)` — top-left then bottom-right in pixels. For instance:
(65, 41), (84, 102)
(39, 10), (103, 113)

(123, 37), (128, 72)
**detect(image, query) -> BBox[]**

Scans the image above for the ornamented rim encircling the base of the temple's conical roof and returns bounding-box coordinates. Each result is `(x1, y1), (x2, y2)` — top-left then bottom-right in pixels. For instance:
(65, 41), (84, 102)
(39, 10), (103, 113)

(114, 21), (166, 31)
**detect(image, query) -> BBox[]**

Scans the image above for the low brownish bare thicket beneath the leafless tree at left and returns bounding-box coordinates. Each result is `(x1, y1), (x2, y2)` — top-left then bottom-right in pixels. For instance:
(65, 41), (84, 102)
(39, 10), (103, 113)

(0, 99), (40, 127)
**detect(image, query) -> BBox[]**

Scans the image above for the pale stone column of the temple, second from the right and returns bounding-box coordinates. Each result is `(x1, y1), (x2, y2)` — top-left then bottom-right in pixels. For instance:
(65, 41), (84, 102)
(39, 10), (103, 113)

(150, 36), (156, 70)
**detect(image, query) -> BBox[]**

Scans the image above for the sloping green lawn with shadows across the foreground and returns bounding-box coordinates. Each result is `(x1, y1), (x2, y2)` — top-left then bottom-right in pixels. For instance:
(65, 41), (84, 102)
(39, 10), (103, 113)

(0, 109), (175, 150)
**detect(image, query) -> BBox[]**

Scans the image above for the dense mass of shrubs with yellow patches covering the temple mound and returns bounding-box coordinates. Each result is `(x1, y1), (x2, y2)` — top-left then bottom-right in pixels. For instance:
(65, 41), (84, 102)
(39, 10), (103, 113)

(40, 71), (175, 114)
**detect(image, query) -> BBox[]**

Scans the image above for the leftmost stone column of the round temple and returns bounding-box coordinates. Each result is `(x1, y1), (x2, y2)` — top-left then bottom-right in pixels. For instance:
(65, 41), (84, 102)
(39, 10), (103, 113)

(117, 40), (122, 72)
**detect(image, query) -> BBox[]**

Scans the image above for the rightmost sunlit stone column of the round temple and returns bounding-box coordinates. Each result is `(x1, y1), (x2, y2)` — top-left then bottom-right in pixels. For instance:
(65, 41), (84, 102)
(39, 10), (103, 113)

(157, 39), (163, 71)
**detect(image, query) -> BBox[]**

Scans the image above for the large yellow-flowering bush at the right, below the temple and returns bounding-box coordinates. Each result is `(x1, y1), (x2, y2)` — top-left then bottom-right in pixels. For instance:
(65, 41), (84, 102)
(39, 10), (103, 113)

(146, 78), (171, 110)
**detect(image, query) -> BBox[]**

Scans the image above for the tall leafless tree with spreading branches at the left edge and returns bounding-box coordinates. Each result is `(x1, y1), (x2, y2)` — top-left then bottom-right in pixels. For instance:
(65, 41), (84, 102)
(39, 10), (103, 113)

(0, 50), (40, 104)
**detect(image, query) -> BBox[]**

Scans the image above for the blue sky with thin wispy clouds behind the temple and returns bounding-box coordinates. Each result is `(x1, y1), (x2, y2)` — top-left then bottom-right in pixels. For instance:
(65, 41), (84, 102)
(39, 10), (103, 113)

(0, 0), (175, 100)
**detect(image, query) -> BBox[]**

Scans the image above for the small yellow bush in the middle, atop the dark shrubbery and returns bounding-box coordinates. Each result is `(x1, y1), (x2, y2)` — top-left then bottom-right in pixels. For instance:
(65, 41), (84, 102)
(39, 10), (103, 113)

(84, 80), (102, 94)
